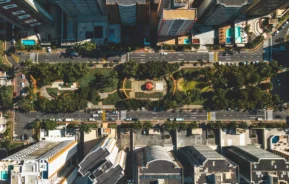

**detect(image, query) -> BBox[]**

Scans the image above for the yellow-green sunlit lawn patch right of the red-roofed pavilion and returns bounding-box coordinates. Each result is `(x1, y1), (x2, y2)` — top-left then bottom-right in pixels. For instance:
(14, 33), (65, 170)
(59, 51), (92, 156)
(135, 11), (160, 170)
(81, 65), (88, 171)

(178, 78), (210, 92)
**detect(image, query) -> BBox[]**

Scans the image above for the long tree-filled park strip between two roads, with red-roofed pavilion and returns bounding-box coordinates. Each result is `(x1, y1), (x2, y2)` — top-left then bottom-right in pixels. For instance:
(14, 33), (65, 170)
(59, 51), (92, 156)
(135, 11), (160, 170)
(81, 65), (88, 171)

(20, 61), (286, 112)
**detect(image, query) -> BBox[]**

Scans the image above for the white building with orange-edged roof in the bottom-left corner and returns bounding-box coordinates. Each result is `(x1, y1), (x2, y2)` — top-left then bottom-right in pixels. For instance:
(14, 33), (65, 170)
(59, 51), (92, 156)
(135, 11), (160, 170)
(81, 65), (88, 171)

(0, 140), (77, 184)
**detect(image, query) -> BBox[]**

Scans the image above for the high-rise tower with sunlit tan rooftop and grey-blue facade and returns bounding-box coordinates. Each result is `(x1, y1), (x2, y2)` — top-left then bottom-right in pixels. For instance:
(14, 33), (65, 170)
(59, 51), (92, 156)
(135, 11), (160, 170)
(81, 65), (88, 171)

(158, 9), (197, 36)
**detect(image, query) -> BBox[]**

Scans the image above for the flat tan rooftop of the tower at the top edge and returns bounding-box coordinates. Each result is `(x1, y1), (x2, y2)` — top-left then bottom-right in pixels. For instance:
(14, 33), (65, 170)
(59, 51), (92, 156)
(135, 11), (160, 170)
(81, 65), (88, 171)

(163, 9), (197, 20)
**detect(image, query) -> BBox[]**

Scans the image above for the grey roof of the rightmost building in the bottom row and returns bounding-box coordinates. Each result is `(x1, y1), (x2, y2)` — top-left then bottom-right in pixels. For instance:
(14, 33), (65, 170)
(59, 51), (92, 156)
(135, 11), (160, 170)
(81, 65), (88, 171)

(230, 145), (283, 162)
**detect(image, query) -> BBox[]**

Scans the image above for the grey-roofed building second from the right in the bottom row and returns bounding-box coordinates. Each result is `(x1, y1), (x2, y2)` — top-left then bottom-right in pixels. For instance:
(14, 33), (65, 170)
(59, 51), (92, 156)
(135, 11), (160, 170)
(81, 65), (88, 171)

(178, 146), (239, 184)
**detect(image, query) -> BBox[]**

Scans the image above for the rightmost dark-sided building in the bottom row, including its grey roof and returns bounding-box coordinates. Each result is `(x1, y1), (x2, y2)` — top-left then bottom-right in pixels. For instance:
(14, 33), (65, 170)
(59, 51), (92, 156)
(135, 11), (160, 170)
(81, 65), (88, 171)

(225, 145), (289, 184)
